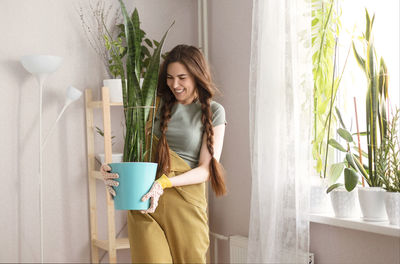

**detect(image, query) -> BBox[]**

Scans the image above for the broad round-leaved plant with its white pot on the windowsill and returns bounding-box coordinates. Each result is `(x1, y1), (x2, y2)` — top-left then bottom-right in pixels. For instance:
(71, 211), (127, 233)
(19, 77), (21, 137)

(326, 108), (359, 218)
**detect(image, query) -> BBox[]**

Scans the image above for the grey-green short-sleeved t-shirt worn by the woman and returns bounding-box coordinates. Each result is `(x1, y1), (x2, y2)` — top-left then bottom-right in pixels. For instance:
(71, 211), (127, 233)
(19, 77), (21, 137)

(154, 101), (226, 168)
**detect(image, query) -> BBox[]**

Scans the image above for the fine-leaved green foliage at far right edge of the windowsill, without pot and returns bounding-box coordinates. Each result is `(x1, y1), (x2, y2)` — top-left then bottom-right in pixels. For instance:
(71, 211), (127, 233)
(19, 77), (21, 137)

(376, 109), (400, 192)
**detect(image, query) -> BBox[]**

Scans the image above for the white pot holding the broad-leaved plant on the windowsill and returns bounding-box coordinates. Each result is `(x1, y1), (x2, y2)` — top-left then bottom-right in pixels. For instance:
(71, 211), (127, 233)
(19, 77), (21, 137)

(329, 186), (359, 218)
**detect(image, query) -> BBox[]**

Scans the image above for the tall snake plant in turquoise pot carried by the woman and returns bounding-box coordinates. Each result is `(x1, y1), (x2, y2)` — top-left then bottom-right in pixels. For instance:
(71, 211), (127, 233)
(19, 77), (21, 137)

(109, 0), (172, 210)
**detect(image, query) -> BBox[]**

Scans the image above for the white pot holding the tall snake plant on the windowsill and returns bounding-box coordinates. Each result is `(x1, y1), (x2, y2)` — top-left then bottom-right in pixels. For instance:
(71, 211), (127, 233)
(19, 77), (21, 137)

(358, 187), (387, 222)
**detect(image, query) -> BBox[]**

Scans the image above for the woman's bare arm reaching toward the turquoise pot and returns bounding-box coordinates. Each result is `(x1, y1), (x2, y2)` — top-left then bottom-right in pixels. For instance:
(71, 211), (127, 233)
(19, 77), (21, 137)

(169, 124), (225, 186)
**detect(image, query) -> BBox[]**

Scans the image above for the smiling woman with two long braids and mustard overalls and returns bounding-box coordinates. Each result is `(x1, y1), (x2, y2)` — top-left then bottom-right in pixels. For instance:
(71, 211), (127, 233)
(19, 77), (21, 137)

(102, 45), (226, 263)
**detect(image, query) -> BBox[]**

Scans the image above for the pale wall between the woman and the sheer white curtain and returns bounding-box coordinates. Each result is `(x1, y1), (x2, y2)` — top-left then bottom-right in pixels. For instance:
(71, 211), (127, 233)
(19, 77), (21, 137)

(208, 0), (252, 263)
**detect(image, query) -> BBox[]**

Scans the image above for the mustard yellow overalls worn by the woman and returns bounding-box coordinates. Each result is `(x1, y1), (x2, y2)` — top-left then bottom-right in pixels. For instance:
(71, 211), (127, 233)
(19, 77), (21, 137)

(128, 99), (209, 263)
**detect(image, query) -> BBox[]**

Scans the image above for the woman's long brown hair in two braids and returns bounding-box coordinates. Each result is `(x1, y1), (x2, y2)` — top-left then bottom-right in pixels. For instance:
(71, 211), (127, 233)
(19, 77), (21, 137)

(156, 45), (226, 196)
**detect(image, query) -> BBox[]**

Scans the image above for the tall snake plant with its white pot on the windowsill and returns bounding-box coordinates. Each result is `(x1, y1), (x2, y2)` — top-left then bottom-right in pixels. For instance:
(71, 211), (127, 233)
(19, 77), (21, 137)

(353, 10), (388, 221)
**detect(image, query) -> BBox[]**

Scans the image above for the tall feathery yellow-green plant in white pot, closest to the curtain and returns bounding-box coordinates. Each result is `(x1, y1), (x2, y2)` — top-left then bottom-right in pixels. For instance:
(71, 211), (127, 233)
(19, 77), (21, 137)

(310, 0), (340, 213)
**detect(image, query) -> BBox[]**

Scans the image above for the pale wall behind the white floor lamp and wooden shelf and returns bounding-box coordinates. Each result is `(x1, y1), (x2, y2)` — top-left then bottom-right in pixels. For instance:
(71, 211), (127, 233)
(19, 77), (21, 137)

(0, 0), (197, 262)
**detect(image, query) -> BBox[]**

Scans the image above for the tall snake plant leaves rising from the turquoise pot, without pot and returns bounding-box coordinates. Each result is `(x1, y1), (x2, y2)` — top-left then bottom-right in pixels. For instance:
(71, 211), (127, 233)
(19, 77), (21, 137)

(115, 0), (172, 162)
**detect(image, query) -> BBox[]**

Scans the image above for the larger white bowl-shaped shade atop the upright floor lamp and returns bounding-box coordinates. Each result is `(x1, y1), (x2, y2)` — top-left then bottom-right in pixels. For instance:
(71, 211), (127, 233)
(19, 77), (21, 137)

(21, 55), (62, 74)
